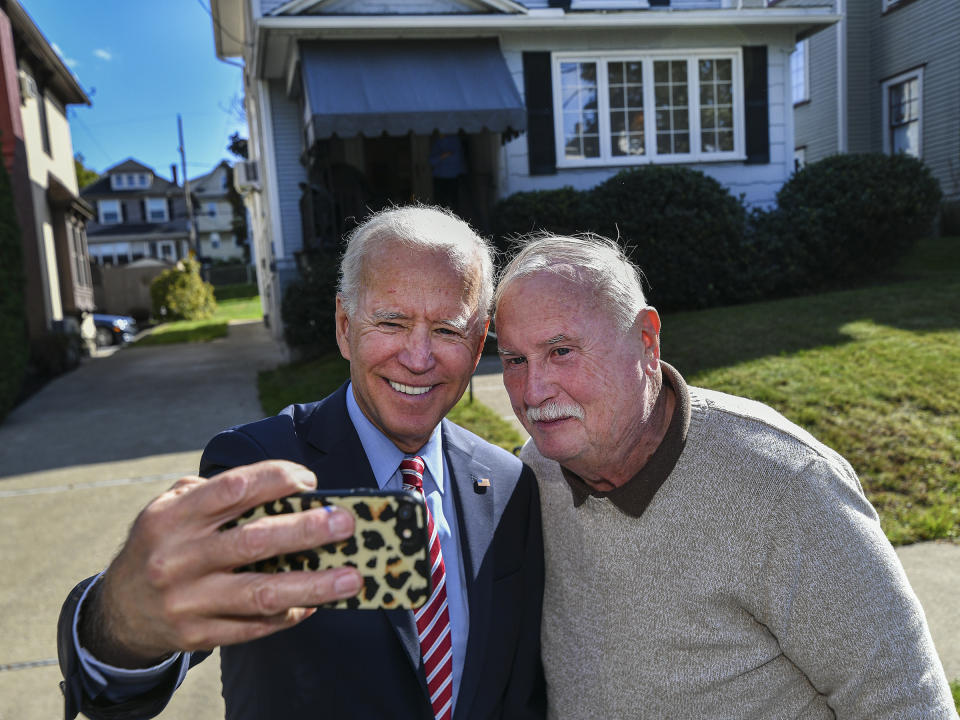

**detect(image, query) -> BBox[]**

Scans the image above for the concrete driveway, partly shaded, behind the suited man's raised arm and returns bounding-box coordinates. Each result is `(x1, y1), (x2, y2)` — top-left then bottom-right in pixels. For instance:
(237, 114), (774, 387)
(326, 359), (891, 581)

(0, 322), (282, 720)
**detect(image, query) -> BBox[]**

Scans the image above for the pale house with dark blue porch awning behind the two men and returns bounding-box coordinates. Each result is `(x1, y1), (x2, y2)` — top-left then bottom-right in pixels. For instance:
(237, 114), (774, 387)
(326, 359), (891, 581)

(211, 0), (840, 337)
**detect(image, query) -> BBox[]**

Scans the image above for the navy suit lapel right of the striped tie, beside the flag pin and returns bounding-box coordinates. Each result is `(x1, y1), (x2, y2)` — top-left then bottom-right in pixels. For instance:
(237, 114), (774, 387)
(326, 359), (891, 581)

(443, 420), (496, 718)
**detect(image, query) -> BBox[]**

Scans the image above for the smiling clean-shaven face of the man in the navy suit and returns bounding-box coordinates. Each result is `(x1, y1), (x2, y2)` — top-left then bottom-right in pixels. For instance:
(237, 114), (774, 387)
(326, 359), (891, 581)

(336, 242), (487, 452)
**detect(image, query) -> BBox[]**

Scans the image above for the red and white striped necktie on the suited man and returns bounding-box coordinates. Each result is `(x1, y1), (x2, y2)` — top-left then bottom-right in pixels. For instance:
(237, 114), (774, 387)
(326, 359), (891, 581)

(400, 457), (453, 720)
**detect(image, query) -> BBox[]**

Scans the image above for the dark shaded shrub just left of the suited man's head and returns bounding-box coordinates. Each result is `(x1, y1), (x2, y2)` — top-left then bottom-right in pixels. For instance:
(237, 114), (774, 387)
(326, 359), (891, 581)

(280, 250), (340, 357)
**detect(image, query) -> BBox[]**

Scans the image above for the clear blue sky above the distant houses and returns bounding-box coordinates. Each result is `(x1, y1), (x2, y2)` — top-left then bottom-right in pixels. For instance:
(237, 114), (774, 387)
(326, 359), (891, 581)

(20, 0), (247, 182)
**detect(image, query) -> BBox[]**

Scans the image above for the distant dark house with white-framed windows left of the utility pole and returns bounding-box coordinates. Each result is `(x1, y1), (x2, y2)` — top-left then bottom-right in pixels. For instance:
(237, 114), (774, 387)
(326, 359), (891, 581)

(80, 158), (190, 265)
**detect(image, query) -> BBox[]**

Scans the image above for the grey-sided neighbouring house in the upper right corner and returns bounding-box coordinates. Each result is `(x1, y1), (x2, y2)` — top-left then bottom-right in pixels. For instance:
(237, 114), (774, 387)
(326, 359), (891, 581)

(780, 0), (960, 201)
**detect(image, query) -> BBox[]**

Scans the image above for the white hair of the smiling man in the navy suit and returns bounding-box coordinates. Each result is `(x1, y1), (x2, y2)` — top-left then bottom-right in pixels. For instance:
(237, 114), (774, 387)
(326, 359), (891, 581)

(337, 205), (493, 320)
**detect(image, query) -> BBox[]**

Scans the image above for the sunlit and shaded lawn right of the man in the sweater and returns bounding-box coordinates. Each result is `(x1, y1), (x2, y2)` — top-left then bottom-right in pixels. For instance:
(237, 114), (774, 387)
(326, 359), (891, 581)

(661, 238), (960, 544)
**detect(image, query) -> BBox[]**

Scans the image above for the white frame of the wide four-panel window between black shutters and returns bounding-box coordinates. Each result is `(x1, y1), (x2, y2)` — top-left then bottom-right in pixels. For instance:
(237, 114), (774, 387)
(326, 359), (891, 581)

(552, 48), (747, 168)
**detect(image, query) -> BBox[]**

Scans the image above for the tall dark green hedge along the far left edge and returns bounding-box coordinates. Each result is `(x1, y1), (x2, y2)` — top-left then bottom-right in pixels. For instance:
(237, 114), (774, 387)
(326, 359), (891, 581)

(0, 152), (29, 419)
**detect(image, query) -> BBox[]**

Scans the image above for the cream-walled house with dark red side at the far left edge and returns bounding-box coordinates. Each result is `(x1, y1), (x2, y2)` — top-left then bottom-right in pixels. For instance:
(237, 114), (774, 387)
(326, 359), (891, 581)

(0, 0), (94, 344)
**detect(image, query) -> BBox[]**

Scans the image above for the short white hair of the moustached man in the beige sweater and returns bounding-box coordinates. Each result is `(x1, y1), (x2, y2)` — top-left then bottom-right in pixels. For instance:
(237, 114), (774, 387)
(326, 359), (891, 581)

(493, 233), (648, 328)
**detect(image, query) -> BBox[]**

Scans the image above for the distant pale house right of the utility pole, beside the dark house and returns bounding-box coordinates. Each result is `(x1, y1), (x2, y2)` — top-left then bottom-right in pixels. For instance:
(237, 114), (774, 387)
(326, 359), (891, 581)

(190, 160), (246, 262)
